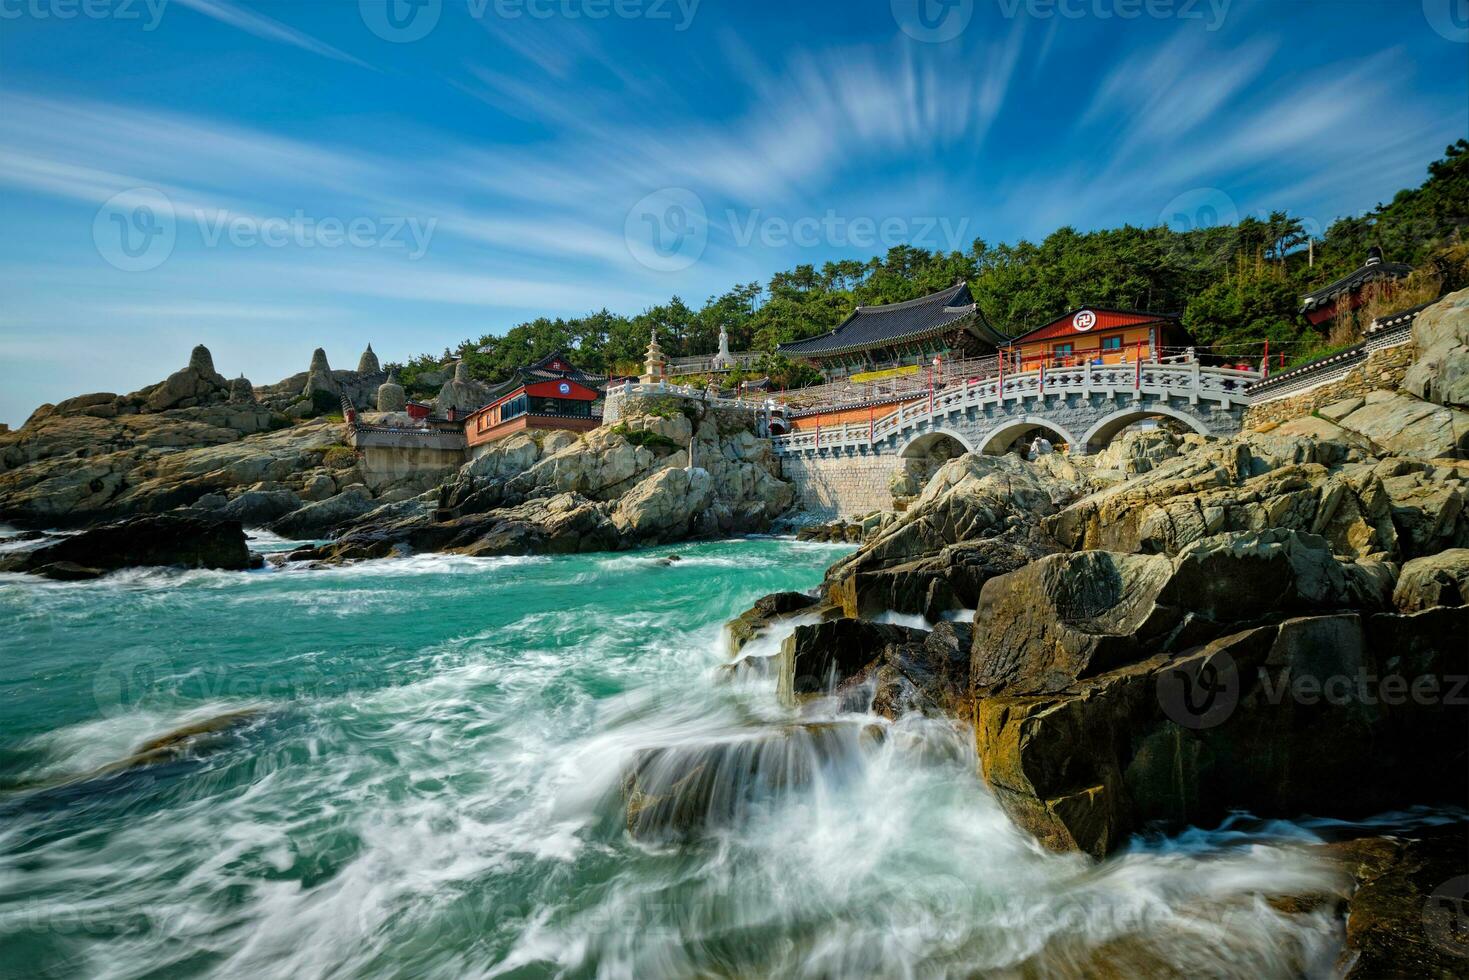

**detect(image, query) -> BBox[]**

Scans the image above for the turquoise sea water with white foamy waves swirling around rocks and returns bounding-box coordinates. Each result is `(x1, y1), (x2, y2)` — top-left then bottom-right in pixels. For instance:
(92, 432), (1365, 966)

(0, 539), (1363, 979)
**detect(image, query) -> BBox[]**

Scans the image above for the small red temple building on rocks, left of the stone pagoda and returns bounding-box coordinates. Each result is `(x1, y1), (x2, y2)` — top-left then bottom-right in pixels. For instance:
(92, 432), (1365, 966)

(464, 351), (607, 455)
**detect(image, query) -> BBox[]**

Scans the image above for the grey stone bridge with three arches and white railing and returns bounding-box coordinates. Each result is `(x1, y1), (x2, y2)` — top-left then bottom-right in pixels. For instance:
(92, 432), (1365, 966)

(774, 360), (1260, 514)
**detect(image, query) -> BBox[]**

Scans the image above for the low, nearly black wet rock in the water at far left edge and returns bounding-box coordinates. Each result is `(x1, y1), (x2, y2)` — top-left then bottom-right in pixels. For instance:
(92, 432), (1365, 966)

(0, 514), (250, 572)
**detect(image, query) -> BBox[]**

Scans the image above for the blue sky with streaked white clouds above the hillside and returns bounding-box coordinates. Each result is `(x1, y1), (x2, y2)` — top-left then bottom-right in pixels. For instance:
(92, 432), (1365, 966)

(0, 0), (1469, 425)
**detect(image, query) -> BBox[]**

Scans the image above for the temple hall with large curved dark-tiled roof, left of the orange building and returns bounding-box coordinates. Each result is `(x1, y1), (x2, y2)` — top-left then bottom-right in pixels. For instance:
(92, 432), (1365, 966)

(777, 281), (1006, 378)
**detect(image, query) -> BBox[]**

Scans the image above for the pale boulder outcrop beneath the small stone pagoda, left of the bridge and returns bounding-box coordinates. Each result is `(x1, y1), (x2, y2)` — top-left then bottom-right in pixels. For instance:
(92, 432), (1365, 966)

(298, 400), (795, 561)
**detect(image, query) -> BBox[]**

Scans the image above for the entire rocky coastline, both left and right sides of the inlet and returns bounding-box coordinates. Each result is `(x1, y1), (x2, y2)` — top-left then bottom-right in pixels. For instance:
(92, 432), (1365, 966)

(0, 291), (1469, 977)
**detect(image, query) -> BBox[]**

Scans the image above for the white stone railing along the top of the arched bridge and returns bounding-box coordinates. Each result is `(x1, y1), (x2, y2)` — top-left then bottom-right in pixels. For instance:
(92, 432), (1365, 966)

(774, 360), (1260, 454)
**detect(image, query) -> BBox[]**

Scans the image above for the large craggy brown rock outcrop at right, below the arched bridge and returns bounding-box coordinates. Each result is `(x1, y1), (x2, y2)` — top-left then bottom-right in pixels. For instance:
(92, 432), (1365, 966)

(730, 287), (1469, 875)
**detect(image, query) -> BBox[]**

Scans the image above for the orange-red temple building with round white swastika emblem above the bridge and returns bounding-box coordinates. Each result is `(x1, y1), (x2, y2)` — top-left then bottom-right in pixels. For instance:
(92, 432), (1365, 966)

(1005, 307), (1193, 372)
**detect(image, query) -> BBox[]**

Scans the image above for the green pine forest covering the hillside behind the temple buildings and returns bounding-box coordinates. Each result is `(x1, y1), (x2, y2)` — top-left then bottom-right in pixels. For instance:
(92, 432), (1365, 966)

(398, 140), (1469, 394)
